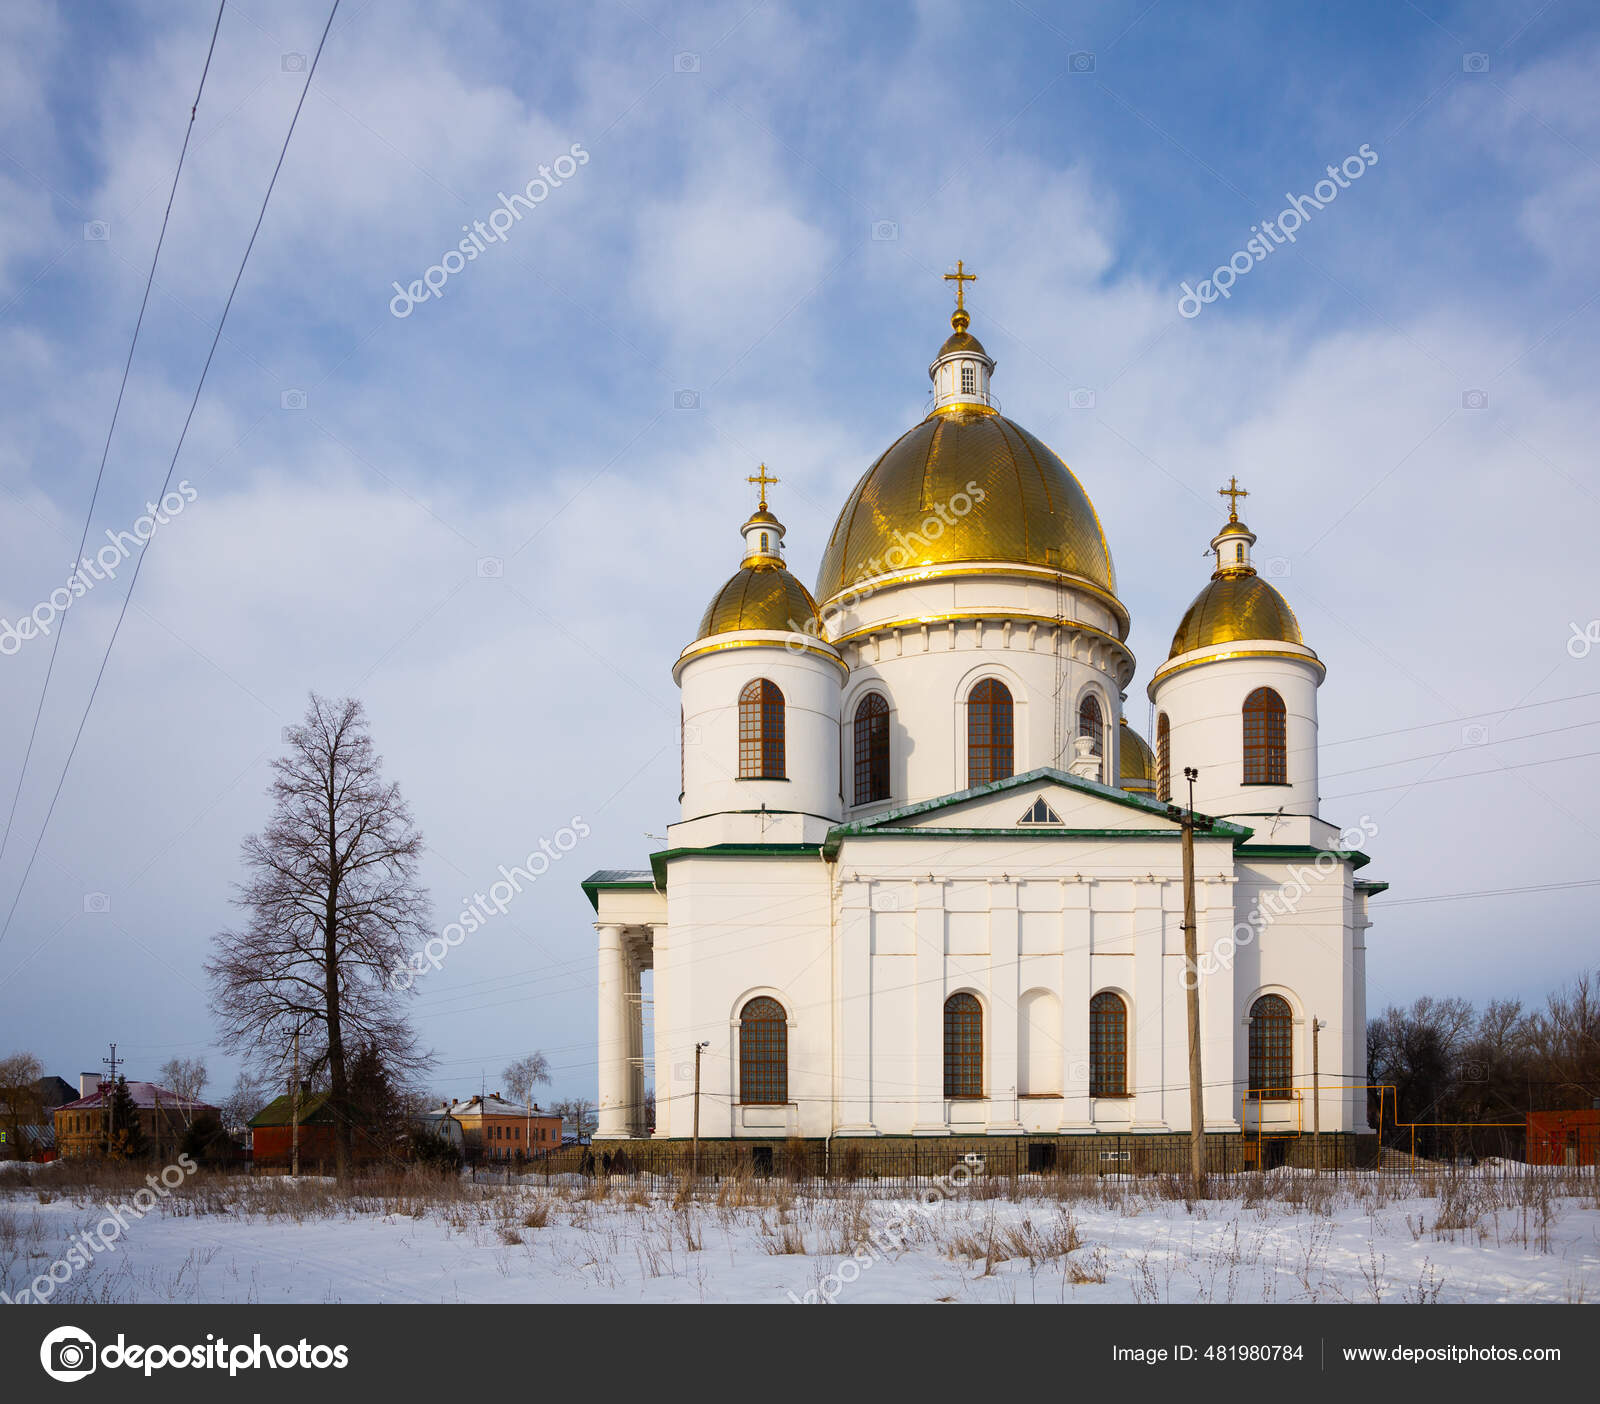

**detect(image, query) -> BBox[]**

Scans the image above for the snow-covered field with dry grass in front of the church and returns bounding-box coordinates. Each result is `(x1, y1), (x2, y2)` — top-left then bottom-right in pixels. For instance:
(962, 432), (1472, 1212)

(0, 1167), (1600, 1305)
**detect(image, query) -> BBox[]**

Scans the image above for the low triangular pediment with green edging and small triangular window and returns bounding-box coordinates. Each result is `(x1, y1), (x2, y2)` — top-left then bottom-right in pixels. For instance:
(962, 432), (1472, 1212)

(829, 768), (1250, 846)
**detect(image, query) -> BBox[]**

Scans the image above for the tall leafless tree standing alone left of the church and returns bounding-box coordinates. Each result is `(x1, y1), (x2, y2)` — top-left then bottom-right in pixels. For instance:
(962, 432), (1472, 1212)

(206, 692), (430, 1179)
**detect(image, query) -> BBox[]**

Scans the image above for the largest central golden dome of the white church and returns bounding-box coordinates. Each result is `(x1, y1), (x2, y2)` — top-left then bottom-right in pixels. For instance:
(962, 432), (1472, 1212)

(816, 403), (1128, 610)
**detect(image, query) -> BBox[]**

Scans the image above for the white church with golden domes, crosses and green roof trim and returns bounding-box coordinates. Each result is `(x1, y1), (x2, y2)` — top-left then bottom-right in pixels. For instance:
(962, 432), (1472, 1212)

(584, 275), (1386, 1163)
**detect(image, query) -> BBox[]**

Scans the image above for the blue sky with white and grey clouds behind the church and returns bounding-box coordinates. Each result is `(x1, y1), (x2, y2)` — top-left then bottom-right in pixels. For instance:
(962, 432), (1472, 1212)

(0, 0), (1600, 1095)
